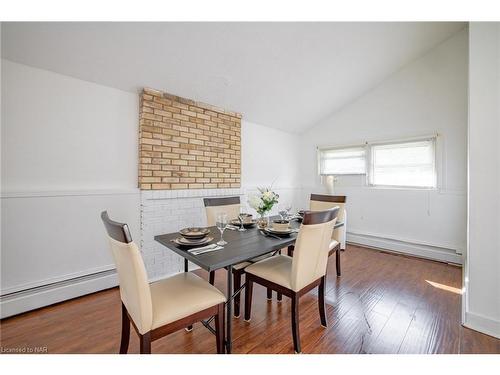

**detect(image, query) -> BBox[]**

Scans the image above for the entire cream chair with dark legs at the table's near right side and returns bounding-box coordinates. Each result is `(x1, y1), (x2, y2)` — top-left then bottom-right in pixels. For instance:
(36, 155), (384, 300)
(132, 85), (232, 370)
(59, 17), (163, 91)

(245, 208), (339, 353)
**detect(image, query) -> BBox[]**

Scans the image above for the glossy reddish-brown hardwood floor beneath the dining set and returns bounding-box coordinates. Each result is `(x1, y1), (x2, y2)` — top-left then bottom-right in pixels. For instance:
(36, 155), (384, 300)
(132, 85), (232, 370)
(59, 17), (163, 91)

(0, 246), (500, 353)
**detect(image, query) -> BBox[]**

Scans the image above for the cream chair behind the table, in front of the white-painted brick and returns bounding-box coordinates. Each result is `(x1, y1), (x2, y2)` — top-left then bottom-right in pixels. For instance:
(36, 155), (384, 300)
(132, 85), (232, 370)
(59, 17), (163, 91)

(203, 196), (272, 317)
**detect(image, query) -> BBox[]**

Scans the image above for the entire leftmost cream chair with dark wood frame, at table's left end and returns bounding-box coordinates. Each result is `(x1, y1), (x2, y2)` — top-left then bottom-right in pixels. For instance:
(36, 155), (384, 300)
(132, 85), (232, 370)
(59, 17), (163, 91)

(101, 211), (226, 354)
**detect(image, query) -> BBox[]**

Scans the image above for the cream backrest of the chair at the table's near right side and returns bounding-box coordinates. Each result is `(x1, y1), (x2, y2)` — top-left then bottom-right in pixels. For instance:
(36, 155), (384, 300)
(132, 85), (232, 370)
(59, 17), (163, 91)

(291, 207), (339, 291)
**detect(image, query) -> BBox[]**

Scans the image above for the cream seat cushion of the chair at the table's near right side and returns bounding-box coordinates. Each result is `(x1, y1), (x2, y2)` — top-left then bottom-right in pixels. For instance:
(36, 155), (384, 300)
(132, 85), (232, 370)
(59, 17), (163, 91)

(245, 254), (292, 289)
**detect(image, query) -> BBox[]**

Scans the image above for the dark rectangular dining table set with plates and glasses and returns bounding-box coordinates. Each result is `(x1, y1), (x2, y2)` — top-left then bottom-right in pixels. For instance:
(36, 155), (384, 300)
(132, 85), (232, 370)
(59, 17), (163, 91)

(154, 216), (344, 354)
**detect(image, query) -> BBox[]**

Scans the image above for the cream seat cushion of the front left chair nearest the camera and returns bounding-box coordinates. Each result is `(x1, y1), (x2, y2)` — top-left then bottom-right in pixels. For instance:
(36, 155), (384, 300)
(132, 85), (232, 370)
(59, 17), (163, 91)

(150, 272), (226, 329)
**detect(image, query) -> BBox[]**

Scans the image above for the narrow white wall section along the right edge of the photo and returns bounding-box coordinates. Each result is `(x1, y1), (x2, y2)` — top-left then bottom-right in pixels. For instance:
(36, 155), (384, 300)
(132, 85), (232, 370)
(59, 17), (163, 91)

(463, 22), (500, 338)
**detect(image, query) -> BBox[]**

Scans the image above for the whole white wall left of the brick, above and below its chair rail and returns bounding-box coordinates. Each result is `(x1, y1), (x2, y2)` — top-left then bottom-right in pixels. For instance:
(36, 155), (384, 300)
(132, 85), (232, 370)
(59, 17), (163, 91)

(1, 60), (140, 316)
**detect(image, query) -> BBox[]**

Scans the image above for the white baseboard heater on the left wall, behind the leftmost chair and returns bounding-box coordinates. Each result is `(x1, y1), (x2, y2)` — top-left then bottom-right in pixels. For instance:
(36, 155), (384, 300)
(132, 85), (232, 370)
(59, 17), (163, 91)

(0, 269), (118, 319)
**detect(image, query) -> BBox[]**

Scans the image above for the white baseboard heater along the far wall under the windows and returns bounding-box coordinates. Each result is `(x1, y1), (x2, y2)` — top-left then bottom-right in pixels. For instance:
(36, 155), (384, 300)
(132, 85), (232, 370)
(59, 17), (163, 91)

(347, 232), (463, 264)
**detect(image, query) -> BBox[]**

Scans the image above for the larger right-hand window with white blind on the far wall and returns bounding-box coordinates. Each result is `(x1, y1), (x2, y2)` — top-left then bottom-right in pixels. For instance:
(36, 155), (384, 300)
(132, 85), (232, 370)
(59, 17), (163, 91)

(369, 138), (436, 188)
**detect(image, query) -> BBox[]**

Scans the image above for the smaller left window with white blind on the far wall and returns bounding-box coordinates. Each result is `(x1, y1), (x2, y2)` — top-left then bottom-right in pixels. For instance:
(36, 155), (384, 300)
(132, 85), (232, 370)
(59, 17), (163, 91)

(319, 147), (366, 175)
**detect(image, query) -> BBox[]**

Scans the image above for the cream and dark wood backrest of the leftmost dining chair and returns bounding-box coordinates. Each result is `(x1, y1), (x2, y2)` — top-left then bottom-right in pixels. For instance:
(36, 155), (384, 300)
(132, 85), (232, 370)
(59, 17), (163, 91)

(101, 211), (153, 334)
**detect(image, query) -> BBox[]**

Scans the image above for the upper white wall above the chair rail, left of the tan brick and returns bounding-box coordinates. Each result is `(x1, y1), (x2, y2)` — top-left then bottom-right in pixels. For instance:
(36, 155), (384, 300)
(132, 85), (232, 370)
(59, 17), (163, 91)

(2, 60), (139, 192)
